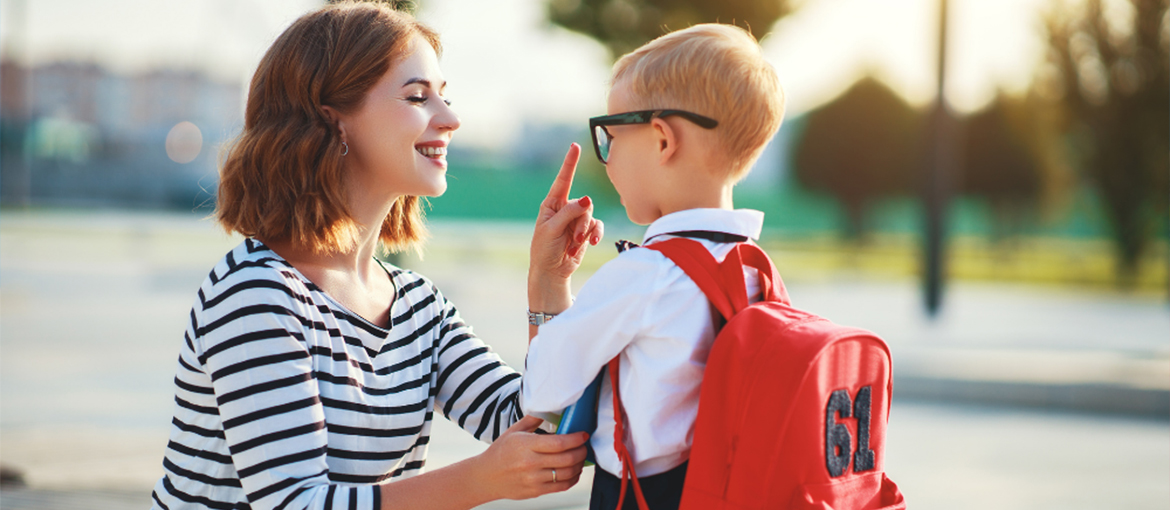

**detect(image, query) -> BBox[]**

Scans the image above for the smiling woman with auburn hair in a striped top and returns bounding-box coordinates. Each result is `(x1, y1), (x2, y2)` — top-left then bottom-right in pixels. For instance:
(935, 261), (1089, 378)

(153, 4), (601, 509)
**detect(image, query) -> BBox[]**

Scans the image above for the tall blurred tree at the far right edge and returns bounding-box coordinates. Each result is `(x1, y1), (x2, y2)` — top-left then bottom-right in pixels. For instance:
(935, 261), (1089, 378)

(1034, 0), (1170, 281)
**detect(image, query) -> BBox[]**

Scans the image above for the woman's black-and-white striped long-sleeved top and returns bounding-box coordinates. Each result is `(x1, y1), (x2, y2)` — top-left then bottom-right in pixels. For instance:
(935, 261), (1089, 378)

(152, 239), (522, 509)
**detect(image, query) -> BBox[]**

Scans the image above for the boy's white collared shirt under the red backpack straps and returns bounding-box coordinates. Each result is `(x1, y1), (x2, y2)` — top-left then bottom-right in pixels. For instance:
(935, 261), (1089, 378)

(521, 204), (764, 477)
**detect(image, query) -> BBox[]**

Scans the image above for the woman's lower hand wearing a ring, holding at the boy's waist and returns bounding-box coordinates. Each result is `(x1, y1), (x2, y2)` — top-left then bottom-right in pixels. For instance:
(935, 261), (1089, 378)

(477, 416), (589, 499)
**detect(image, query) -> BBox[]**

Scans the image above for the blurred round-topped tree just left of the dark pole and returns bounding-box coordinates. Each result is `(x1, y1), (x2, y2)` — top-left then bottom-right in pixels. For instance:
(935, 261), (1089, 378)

(796, 77), (925, 240)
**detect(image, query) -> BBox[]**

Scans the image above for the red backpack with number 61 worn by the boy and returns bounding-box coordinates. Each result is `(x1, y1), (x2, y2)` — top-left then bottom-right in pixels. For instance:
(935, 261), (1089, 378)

(610, 239), (906, 510)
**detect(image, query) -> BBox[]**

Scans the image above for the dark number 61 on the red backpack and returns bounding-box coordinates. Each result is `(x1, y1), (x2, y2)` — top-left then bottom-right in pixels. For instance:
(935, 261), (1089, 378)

(825, 386), (874, 477)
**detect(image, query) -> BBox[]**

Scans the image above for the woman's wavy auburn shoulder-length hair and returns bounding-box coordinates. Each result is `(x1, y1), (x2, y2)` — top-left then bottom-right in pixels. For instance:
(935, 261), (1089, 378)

(215, 2), (441, 253)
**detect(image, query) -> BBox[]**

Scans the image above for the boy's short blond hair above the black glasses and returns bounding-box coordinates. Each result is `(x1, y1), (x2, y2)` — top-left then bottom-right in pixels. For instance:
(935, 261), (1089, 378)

(613, 23), (784, 181)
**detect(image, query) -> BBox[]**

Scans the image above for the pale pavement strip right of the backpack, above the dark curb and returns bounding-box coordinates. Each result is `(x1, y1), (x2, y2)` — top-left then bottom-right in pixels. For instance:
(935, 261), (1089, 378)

(791, 278), (1170, 419)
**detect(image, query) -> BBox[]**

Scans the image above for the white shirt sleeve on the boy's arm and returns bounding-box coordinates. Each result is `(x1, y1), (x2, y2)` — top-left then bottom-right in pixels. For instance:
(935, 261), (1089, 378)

(522, 249), (663, 415)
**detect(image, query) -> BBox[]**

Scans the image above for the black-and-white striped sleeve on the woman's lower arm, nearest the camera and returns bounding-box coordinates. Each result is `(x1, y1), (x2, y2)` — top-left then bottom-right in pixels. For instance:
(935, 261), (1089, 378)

(192, 266), (380, 509)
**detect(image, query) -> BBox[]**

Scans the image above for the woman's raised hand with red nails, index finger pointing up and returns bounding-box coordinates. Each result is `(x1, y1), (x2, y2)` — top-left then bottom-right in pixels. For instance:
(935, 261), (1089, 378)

(528, 144), (605, 313)
